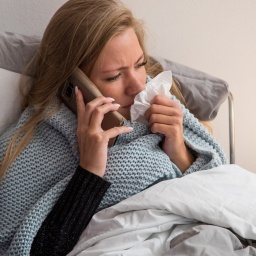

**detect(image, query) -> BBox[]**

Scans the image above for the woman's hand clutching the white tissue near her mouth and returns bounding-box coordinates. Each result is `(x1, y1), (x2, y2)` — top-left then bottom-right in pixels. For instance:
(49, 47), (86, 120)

(145, 95), (194, 172)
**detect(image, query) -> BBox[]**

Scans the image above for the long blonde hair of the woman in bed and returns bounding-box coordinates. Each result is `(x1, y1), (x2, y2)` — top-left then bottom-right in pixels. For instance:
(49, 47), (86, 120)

(0, 0), (211, 177)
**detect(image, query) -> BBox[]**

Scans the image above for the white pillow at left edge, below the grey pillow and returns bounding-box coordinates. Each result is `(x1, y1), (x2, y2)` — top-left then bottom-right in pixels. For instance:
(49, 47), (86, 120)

(0, 68), (29, 134)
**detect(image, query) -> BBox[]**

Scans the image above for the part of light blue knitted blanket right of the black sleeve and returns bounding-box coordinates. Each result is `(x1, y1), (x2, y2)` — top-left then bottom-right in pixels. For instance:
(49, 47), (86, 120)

(98, 96), (226, 210)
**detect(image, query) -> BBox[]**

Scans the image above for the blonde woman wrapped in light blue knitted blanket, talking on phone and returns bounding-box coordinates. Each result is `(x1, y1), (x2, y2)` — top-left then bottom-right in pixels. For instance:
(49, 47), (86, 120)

(0, 0), (225, 255)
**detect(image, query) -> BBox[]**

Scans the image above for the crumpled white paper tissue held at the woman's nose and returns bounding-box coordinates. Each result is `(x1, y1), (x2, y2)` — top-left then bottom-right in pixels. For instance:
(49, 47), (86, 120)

(131, 70), (172, 124)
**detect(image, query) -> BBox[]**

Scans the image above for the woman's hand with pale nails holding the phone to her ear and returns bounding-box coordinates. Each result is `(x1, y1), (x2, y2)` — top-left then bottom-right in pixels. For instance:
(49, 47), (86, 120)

(76, 88), (132, 177)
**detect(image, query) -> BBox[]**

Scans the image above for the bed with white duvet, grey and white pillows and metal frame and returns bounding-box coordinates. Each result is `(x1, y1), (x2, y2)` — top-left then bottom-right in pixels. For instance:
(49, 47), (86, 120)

(0, 32), (256, 256)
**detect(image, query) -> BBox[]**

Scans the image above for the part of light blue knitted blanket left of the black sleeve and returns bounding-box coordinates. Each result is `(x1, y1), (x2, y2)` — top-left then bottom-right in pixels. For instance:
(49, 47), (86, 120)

(0, 104), (78, 255)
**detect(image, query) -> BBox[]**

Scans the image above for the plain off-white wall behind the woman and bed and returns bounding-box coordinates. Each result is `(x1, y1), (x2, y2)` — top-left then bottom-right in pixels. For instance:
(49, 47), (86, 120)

(0, 0), (256, 171)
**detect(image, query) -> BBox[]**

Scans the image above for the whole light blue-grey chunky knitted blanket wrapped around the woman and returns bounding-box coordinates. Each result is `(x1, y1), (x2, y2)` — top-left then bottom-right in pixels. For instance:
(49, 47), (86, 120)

(0, 95), (226, 255)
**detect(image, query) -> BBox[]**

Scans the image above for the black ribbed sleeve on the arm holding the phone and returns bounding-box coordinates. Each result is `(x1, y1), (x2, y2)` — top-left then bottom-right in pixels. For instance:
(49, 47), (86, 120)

(30, 166), (110, 256)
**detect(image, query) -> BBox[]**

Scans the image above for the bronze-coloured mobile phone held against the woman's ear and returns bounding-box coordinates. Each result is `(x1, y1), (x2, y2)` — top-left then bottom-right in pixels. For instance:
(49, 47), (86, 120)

(59, 68), (125, 147)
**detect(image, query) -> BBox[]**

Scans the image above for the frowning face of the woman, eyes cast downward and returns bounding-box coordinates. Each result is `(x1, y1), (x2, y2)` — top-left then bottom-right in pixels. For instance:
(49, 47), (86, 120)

(87, 28), (146, 120)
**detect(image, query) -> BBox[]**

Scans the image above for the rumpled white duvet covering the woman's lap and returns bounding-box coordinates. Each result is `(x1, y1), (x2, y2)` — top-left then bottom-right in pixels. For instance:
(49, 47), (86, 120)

(68, 165), (256, 256)
